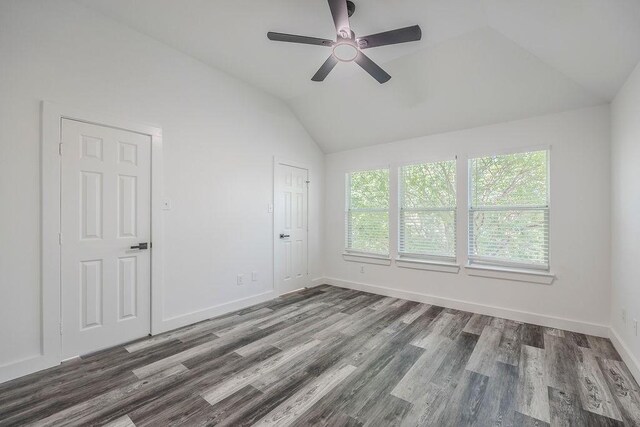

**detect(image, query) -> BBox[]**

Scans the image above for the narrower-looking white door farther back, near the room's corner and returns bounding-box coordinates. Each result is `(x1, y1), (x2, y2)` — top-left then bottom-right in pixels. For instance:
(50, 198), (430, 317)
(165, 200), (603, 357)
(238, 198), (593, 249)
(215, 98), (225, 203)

(274, 163), (309, 294)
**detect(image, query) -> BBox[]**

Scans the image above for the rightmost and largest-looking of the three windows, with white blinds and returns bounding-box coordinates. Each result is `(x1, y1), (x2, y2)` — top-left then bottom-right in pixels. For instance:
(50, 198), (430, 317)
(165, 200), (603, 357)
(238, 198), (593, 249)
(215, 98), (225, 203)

(469, 151), (549, 270)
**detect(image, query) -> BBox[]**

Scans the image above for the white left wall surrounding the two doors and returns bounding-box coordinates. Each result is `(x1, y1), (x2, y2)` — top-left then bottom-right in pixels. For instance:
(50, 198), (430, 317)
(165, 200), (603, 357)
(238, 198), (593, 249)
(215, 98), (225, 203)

(0, 0), (324, 378)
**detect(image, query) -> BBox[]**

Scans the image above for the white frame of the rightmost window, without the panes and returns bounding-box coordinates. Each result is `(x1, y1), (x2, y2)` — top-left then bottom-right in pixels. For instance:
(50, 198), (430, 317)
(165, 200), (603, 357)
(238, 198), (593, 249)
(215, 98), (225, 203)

(467, 146), (551, 273)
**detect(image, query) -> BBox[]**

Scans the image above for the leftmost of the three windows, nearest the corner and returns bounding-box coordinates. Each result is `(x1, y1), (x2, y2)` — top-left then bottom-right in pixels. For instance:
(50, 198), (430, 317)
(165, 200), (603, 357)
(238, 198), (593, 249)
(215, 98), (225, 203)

(345, 169), (389, 255)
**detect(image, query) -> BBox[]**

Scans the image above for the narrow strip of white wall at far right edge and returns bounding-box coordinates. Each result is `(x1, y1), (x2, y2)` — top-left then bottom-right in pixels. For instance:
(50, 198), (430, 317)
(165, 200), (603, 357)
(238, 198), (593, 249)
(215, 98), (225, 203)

(611, 61), (640, 372)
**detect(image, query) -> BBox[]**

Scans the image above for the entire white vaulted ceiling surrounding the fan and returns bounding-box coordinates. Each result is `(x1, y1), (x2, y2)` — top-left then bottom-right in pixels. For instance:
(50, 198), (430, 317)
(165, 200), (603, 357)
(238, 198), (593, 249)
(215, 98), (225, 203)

(77, 0), (640, 152)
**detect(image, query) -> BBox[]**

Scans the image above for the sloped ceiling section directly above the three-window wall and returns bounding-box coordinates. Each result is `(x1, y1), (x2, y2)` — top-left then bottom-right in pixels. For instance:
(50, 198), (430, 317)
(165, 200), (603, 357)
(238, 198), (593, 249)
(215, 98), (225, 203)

(289, 28), (607, 153)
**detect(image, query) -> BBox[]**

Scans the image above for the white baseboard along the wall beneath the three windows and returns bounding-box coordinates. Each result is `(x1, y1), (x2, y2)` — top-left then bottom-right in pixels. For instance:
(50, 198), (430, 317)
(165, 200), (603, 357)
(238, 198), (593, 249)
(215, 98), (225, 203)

(324, 277), (610, 337)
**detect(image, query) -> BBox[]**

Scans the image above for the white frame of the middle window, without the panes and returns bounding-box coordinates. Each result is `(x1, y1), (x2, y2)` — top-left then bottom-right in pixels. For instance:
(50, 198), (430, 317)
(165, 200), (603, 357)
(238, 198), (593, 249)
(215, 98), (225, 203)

(397, 156), (458, 264)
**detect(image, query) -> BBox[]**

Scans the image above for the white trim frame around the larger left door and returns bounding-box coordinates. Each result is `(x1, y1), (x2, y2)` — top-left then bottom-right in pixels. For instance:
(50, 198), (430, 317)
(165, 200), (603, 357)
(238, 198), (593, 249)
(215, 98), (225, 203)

(35, 101), (164, 380)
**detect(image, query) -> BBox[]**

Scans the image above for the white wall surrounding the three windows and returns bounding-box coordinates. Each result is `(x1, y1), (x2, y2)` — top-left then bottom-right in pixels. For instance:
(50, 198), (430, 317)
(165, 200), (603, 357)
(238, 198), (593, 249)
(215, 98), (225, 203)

(324, 106), (610, 334)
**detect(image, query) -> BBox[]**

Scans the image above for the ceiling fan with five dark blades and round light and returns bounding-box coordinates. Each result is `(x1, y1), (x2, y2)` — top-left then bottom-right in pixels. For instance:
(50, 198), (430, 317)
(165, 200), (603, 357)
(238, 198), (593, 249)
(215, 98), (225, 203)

(267, 0), (422, 83)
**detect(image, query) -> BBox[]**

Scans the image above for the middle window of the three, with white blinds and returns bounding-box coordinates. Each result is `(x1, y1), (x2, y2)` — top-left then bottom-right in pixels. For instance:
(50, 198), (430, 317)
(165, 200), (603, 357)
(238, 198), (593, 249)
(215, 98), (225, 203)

(398, 160), (456, 262)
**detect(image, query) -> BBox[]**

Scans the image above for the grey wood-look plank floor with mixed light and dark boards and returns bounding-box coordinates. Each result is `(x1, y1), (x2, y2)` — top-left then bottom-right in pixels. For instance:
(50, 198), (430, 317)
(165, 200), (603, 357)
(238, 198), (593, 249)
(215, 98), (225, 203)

(0, 286), (640, 426)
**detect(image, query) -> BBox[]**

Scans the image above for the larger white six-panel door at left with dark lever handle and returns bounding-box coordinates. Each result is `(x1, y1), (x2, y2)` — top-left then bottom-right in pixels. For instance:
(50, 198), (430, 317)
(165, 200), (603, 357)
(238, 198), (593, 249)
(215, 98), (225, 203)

(61, 119), (151, 358)
